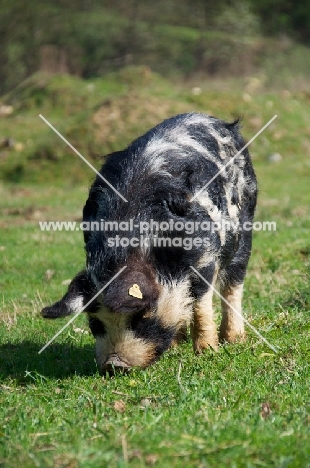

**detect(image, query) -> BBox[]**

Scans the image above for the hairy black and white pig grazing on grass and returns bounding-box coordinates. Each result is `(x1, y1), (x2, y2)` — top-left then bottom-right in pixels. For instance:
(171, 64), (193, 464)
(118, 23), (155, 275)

(42, 113), (257, 373)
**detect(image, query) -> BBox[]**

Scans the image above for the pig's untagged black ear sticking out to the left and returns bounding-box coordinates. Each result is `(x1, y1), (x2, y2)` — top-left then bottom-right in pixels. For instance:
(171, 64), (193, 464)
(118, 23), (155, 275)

(41, 271), (94, 319)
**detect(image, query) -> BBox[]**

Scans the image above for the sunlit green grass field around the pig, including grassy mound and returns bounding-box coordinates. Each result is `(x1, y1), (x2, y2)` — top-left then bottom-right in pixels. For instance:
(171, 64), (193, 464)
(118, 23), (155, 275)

(0, 67), (310, 468)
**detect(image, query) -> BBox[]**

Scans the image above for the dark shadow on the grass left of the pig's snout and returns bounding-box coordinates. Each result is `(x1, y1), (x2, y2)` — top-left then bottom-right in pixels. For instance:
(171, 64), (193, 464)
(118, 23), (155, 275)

(0, 341), (97, 385)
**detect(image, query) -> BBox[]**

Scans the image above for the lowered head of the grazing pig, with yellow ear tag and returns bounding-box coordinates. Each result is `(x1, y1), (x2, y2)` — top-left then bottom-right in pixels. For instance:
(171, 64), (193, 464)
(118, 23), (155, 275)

(42, 254), (191, 374)
